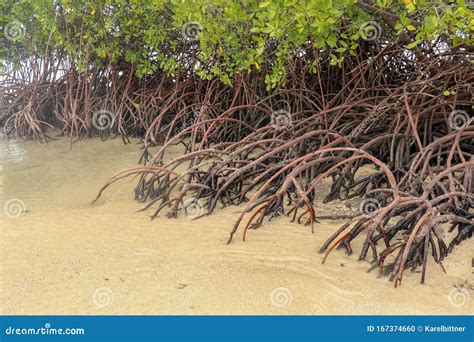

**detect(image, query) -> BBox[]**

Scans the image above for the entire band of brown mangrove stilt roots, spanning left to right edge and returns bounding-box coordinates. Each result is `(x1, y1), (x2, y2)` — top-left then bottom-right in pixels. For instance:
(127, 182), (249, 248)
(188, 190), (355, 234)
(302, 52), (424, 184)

(0, 24), (474, 285)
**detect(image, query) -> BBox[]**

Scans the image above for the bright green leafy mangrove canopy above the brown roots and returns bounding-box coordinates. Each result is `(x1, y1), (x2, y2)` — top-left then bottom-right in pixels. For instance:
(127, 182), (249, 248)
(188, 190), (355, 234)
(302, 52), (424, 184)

(0, 0), (474, 88)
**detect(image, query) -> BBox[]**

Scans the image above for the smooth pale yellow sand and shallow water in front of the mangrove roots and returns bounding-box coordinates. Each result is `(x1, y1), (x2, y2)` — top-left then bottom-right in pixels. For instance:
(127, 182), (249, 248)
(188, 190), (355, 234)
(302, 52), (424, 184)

(0, 138), (474, 314)
